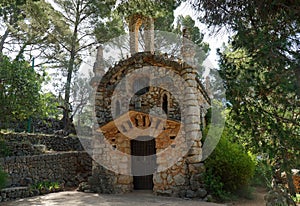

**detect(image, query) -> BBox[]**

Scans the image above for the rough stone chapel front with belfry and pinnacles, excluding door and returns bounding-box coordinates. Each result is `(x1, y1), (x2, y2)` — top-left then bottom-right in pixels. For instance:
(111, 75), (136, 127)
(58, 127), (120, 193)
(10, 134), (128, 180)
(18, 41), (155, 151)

(89, 14), (210, 198)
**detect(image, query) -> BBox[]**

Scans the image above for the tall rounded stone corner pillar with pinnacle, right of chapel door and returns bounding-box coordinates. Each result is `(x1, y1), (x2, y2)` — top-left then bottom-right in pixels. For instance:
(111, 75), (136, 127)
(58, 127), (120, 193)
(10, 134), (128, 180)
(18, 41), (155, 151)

(181, 28), (207, 198)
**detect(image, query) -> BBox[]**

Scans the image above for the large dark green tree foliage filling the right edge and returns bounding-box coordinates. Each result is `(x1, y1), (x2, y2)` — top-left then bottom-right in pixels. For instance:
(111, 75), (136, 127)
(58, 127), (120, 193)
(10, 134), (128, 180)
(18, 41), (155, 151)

(189, 0), (300, 195)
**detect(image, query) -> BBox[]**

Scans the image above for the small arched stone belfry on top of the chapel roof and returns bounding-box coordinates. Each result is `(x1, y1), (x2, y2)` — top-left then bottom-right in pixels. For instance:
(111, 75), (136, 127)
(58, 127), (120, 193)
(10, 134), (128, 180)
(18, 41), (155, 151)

(129, 14), (154, 55)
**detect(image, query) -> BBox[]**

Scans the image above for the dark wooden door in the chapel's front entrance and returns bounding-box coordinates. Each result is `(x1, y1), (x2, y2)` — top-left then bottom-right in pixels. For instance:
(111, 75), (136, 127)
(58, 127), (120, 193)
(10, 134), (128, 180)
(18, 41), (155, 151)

(131, 136), (156, 190)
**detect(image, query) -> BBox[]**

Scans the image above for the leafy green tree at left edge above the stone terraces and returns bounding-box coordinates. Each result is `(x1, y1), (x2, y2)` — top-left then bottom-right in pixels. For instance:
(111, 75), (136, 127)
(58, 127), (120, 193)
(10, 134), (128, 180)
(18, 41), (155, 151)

(0, 56), (43, 127)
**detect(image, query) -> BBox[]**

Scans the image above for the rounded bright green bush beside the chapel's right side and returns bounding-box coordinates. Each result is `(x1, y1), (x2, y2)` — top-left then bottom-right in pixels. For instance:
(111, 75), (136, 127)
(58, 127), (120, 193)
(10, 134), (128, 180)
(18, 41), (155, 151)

(205, 133), (255, 200)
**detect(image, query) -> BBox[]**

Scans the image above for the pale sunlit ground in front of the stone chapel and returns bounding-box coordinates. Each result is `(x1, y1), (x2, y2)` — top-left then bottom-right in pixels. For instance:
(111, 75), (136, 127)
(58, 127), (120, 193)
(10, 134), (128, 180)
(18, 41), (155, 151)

(1, 191), (222, 206)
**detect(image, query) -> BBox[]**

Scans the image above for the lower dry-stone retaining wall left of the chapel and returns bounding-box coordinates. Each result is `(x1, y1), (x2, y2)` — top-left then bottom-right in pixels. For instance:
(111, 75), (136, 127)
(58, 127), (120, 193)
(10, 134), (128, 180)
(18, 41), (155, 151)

(0, 152), (92, 187)
